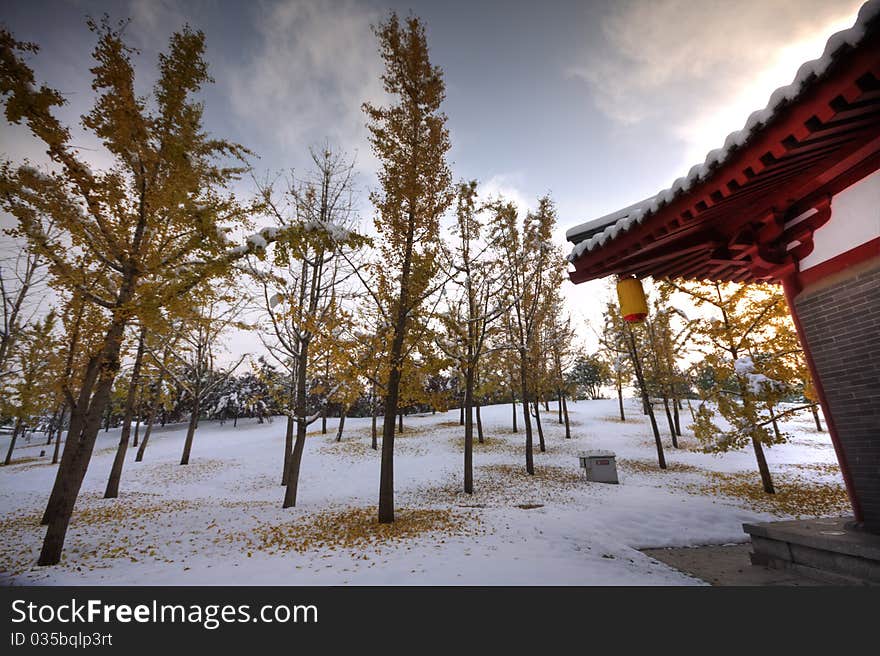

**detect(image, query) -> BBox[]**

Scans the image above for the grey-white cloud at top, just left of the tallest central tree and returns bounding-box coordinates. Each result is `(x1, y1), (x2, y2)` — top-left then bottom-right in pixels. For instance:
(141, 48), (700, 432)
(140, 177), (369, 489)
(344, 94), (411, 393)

(224, 0), (384, 171)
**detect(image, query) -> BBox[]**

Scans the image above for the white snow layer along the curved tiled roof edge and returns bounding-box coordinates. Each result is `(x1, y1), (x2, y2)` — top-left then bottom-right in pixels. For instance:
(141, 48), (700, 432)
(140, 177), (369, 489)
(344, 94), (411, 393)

(565, 0), (880, 262)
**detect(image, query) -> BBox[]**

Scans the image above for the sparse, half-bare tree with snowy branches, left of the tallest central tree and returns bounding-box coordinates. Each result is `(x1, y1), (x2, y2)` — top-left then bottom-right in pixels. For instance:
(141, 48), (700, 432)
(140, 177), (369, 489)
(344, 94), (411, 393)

(253, 147), (368, 508)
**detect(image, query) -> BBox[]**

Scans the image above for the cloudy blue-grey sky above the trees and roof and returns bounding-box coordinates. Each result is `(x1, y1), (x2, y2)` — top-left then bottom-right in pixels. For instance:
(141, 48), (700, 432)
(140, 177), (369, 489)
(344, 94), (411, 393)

(0, 0), (861, 362)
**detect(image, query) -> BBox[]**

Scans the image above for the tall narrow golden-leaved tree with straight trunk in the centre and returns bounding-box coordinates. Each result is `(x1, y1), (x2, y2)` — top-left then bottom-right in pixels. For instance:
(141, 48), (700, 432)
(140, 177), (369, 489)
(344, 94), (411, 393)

(363, 12), (452, 523)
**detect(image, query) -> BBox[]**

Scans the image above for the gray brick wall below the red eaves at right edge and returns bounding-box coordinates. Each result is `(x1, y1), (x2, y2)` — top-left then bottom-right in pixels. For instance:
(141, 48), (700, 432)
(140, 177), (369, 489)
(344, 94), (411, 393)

(795, 266), (880, 533)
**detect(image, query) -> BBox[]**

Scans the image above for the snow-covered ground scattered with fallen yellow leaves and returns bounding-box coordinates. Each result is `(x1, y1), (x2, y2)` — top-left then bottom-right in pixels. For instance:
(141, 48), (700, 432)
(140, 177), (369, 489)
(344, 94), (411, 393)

(0, 400), (846, 585)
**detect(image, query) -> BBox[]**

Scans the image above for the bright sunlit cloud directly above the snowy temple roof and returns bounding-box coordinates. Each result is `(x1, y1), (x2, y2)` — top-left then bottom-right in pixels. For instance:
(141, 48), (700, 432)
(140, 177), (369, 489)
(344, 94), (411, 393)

(567, 0), (861, 159)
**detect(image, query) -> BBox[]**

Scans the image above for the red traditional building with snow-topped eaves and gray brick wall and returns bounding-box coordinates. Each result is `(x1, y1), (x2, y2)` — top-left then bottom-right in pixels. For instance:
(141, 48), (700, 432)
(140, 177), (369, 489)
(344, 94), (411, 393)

(567, 0), (880, 574)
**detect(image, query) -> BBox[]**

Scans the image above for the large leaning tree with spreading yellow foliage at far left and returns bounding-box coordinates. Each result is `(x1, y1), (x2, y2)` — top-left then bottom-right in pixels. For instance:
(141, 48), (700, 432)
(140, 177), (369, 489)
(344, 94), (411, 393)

(0, 20), (286, 565)
